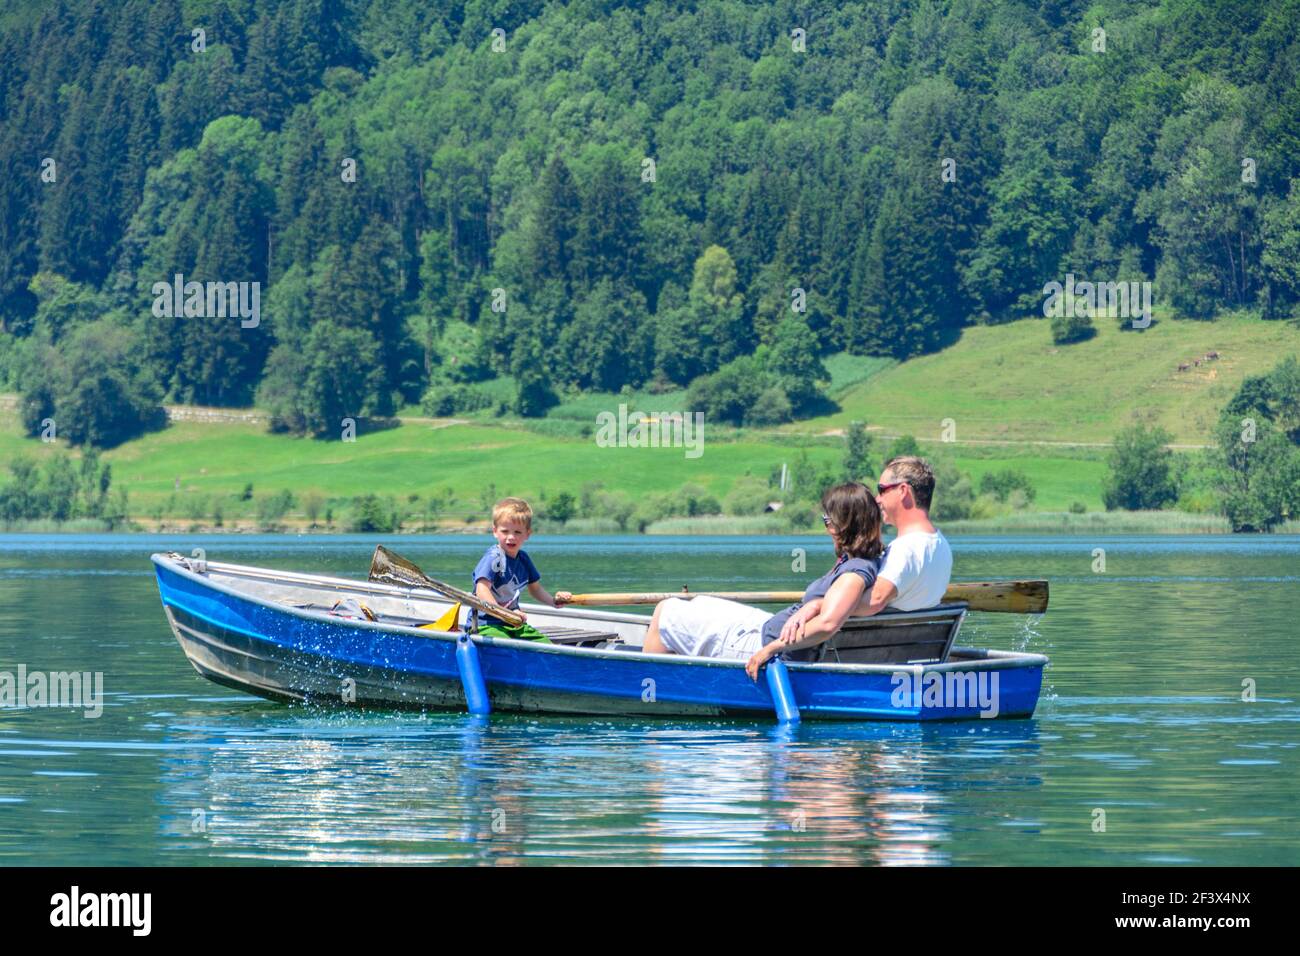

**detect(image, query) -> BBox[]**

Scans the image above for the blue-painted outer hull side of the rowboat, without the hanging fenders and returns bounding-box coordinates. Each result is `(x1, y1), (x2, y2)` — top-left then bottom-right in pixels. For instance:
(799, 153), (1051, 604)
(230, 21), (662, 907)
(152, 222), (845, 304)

(153, 555), (1047, 721)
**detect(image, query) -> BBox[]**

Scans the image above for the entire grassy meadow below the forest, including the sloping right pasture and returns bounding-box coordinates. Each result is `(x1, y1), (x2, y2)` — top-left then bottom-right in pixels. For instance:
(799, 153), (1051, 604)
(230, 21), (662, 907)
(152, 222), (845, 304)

(0, 310), (1300, 529)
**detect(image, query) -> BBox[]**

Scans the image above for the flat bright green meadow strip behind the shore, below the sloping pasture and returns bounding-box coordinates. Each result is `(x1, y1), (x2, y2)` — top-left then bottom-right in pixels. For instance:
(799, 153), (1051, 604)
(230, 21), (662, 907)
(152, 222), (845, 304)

(0, 411), (1105, 514)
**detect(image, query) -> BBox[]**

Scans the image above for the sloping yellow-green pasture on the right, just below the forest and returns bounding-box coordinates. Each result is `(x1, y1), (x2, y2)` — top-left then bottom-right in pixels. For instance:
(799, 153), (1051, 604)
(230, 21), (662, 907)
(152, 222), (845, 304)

(787, 311), (1300, 444)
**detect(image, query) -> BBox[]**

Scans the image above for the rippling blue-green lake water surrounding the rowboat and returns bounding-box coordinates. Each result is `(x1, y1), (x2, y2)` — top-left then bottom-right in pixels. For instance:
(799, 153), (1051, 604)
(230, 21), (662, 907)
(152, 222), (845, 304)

(0, 535), (1300, 866)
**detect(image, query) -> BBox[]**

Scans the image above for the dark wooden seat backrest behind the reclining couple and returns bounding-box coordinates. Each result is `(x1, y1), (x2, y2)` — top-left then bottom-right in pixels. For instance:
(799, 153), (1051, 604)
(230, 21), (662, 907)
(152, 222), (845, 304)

(815, 605), (966, 663)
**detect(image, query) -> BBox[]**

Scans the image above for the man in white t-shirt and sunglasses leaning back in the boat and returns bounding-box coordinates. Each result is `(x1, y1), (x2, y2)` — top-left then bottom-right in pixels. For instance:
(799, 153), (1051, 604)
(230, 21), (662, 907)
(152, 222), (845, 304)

(781, 455), (953, 644)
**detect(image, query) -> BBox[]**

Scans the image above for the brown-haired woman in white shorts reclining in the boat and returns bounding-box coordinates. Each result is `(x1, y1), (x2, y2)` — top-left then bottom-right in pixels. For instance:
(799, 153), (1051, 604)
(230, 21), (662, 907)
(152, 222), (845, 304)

(645, 481), (884, 680)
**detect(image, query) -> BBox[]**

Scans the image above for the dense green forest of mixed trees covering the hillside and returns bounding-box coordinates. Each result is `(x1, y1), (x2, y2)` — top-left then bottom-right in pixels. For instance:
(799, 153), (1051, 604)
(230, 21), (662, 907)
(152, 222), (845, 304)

(0, 0), (1300, 445)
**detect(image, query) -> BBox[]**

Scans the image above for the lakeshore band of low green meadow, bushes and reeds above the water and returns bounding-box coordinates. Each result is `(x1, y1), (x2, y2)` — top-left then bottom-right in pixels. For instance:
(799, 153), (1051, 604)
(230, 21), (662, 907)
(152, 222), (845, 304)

(0, 330), (1300, 535)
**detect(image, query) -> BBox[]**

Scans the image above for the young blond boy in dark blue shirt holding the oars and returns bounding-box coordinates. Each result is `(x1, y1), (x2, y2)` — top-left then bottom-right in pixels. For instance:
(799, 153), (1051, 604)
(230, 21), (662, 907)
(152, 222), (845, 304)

(475, 498), (573, 644)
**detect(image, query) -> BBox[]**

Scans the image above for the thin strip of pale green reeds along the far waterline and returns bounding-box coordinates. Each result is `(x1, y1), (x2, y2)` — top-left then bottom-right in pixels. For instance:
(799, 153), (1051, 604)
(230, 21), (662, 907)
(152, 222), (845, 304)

(0, 510), (1300, 537)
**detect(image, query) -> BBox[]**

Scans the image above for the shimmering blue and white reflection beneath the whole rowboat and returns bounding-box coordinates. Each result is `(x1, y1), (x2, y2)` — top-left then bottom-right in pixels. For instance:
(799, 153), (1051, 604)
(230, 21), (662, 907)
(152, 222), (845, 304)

(154, 710), (1040, 866)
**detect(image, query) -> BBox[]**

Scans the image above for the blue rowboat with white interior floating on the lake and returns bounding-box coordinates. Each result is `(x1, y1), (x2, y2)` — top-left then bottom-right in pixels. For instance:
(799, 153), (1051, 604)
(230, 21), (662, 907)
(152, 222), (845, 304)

(152, 553), (1048, 721)
